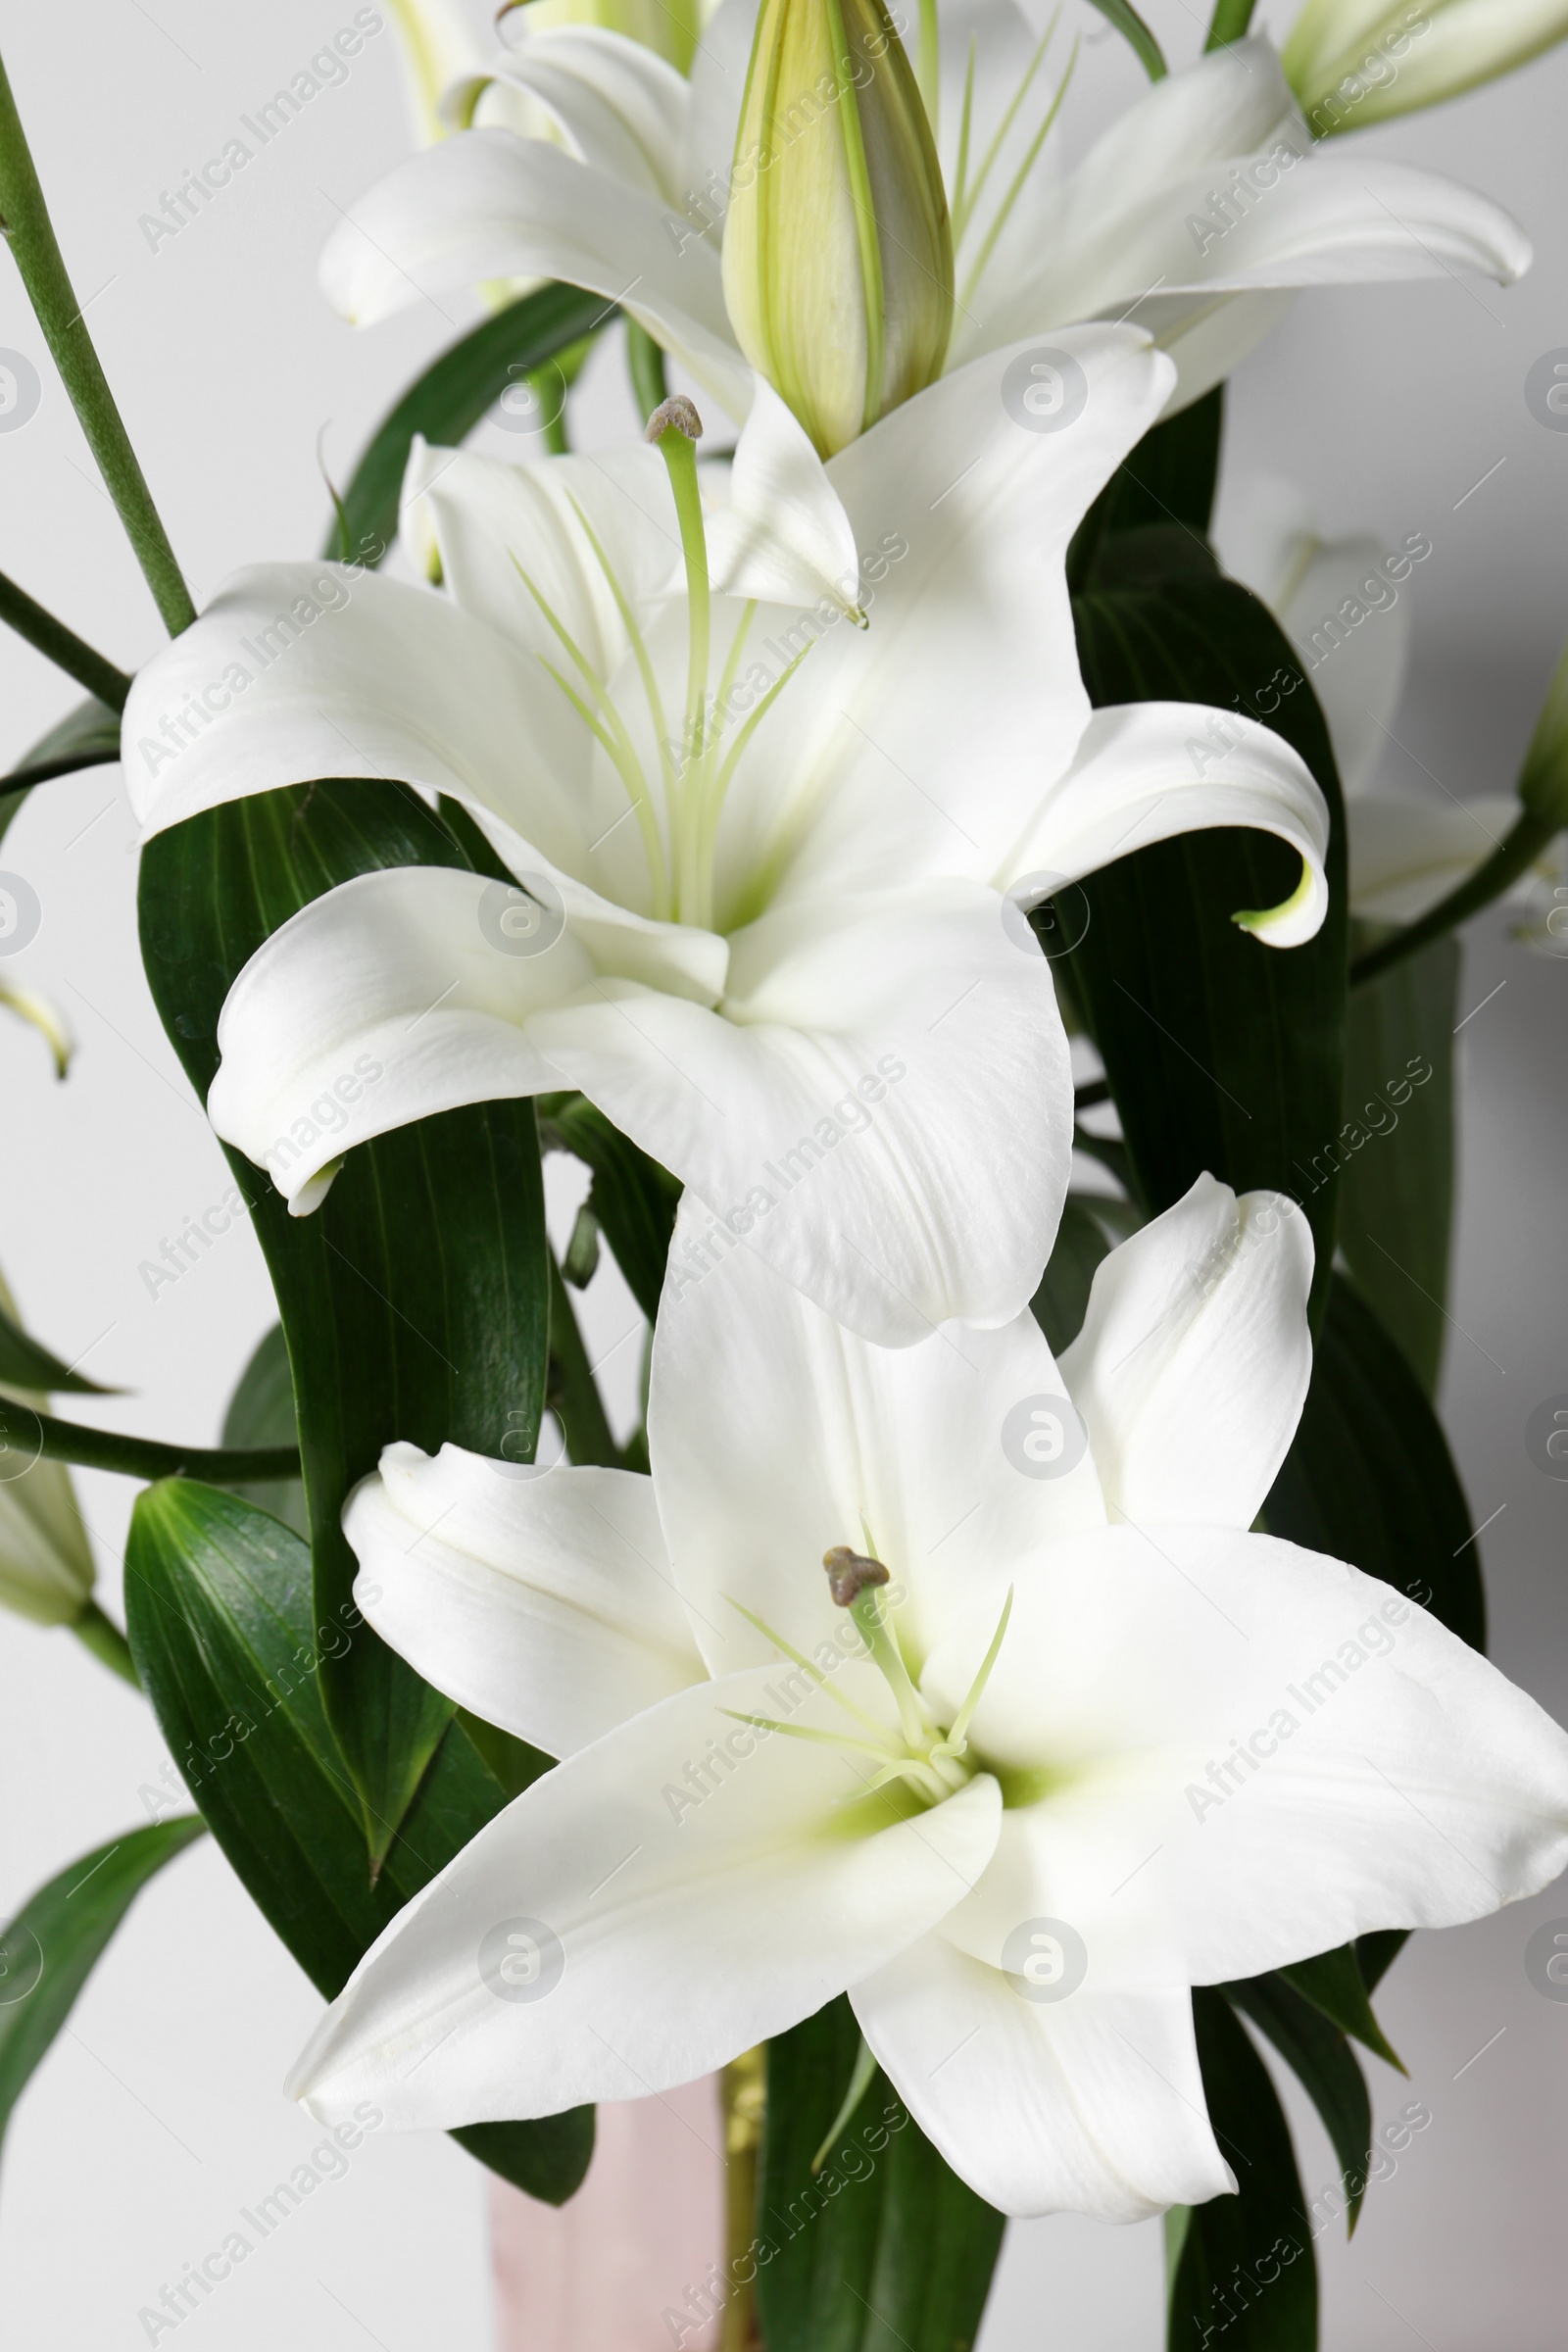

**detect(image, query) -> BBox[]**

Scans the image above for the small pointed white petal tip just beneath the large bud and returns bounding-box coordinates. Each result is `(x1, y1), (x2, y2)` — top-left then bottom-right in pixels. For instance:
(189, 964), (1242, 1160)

(708, 376), (860, 612)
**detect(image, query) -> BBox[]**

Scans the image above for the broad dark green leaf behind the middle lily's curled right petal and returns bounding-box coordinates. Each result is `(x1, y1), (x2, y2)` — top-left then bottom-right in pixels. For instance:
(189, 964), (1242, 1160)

(1065, 578), (1348, 1312)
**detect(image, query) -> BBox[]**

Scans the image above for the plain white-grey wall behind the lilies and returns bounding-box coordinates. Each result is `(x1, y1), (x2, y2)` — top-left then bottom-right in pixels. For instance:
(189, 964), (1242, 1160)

(0, 0), (1568, 2352)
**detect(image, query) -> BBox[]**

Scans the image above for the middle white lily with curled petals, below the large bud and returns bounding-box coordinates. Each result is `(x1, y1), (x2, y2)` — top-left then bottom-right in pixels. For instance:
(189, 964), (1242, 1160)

(124, 341), (1326, 1343)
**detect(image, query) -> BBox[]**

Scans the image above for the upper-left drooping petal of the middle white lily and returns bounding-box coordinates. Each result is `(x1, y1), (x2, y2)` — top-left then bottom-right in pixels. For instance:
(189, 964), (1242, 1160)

(120, 564), (590, 872)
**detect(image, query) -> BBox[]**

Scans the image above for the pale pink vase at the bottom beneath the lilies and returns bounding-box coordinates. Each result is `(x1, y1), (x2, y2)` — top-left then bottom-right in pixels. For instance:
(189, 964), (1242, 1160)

(489, 2075), (724, 2352)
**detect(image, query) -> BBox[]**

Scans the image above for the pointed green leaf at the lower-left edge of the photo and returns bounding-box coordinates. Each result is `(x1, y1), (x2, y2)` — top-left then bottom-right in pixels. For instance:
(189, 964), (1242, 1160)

(0, 1816), (205, 2135)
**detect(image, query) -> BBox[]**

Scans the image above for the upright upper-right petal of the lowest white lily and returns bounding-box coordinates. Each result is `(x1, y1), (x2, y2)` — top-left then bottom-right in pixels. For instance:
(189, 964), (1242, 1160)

(1062, 1176), (1312, 1527)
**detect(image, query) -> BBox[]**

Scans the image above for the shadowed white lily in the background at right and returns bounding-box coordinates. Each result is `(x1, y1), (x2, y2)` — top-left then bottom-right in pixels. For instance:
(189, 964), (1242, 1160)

(1215, 482), (1556, 922)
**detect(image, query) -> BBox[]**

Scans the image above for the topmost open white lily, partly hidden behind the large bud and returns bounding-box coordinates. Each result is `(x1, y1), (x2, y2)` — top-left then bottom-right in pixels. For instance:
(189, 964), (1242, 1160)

(322, 0), (1531, 418)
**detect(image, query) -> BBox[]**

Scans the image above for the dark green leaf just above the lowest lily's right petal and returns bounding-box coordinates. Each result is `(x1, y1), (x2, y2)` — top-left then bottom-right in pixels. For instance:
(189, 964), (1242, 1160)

(1262, 1275), (1486, 1648)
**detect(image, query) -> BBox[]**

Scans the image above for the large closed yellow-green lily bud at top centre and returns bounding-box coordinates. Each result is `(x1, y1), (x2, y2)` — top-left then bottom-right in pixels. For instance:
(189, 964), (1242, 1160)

(724, 0), (953, 457)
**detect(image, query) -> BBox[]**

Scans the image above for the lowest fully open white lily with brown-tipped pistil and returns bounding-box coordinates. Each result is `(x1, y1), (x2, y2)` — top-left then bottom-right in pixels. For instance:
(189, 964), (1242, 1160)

(291, 1176), (1568, 2221)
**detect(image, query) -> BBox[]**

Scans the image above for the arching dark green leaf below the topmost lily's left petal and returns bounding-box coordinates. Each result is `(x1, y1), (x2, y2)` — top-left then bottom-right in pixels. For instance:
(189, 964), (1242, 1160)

(326, 284), (615, 564)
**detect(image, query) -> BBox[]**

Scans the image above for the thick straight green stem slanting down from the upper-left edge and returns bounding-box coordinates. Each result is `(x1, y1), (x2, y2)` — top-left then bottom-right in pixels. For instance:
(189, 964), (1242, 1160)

(0, 45), (195, 637)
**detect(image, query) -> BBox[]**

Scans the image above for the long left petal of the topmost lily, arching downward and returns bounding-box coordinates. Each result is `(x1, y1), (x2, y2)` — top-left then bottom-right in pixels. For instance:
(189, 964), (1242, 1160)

(322, 129), (753, 416)
